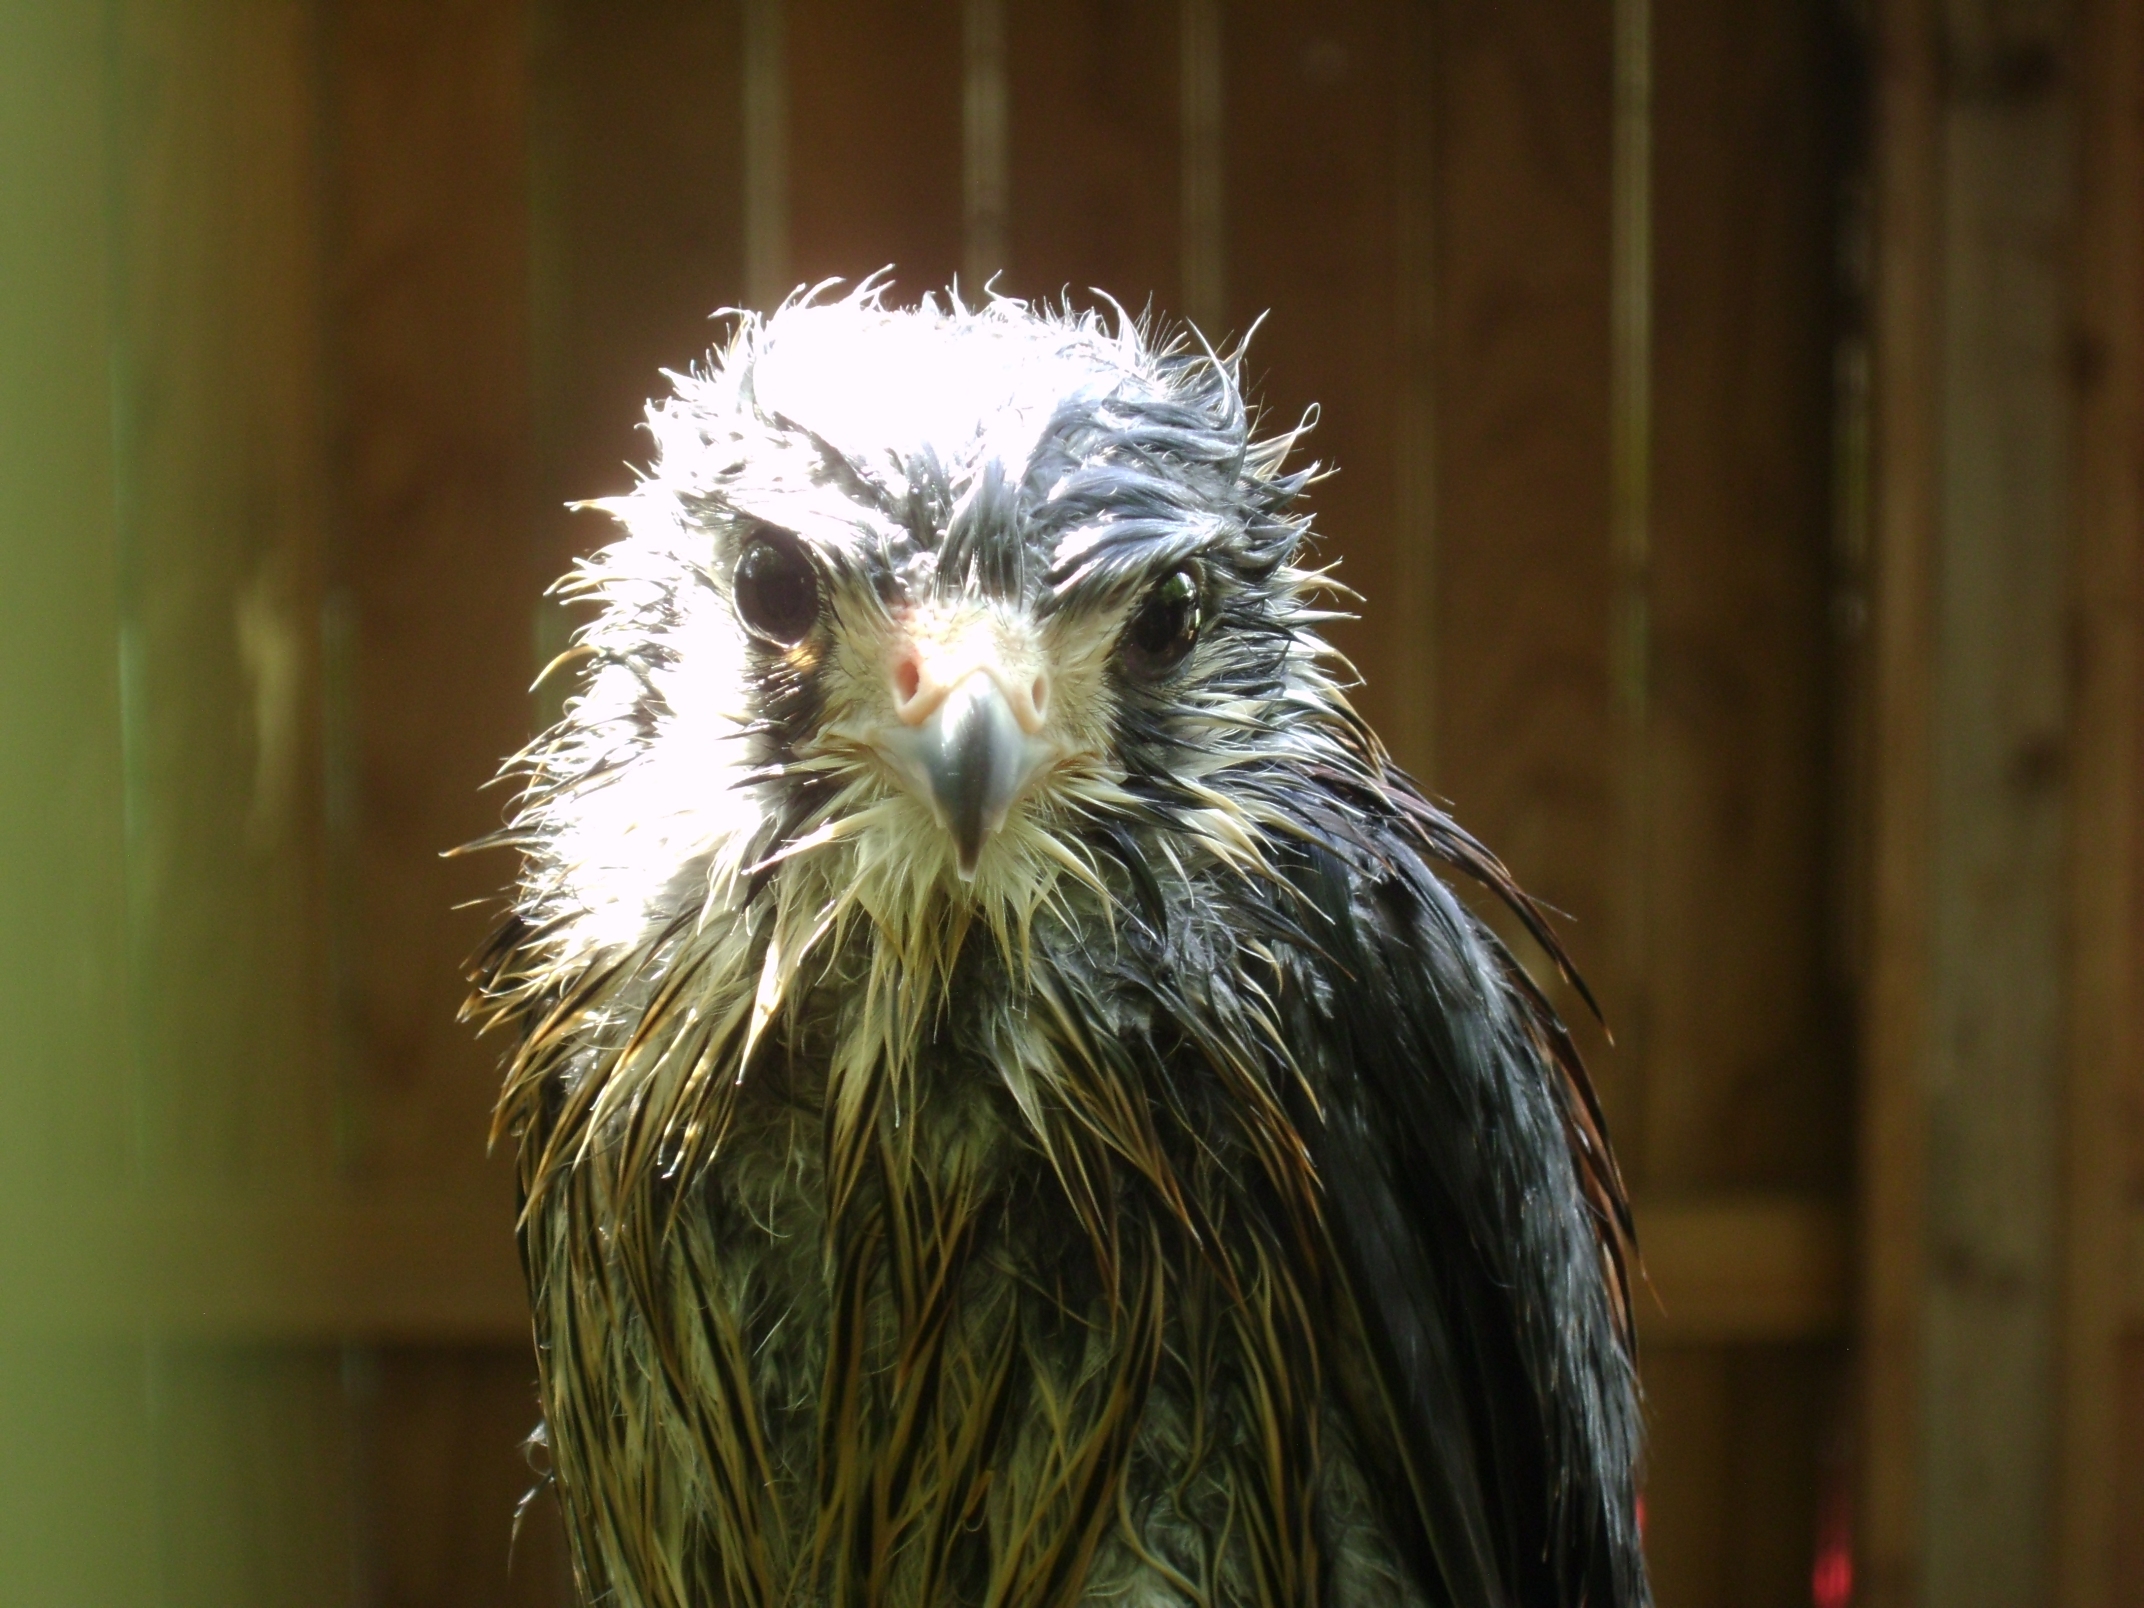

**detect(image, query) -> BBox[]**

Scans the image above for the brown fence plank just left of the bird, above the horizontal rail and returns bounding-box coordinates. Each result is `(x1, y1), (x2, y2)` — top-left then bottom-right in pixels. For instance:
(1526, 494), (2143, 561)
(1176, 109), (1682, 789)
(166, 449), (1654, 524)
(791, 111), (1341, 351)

(326, 0), (549, 1179)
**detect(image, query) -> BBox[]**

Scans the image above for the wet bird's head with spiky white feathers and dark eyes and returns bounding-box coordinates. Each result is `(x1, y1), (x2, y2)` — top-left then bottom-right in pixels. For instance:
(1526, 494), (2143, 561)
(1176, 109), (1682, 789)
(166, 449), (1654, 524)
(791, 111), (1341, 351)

(495, 283), (1344, 1076)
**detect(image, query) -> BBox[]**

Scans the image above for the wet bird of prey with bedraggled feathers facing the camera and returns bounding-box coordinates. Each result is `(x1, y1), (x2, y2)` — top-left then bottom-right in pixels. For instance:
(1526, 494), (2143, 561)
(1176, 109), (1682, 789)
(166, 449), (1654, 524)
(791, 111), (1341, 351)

(472, 281), (1647, 1608)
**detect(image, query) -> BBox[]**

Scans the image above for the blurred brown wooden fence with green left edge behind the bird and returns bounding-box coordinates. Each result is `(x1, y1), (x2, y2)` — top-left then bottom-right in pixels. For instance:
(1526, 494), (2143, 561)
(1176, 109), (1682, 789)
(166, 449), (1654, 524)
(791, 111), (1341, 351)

(0, 0), (2144, 1608)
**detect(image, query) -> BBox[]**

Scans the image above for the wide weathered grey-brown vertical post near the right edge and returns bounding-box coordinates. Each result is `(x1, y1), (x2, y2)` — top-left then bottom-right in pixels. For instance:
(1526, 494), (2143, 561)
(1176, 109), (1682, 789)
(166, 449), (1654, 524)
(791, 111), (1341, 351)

(1863, 0), (2105, 1604)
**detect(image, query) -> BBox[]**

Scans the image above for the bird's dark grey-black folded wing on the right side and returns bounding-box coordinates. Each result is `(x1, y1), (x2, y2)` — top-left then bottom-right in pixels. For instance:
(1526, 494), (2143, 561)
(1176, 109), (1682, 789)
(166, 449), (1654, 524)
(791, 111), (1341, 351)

(1260, 772), (1647, 1608)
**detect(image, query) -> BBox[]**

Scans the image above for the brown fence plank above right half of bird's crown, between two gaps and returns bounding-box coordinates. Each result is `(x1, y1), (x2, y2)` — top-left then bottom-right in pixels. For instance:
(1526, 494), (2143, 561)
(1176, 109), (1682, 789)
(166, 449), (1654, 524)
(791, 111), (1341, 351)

(1003, 0), (1186, 317)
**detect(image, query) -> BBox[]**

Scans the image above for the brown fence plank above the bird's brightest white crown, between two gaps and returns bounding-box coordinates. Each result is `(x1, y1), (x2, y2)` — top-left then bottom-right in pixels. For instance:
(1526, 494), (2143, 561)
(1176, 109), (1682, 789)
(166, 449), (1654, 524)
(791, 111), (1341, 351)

(785, 0), (960, 302)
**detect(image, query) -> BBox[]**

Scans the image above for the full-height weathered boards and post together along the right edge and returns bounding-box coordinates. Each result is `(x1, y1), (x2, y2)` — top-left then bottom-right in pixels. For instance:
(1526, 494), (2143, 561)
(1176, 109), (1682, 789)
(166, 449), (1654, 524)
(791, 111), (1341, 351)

(1861, 0), (2144, 1606)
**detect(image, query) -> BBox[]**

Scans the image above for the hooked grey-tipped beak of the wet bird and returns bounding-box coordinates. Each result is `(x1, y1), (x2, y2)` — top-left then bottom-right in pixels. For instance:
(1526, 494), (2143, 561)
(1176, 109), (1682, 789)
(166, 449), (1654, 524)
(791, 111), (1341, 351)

(879, 667), (1057, 881)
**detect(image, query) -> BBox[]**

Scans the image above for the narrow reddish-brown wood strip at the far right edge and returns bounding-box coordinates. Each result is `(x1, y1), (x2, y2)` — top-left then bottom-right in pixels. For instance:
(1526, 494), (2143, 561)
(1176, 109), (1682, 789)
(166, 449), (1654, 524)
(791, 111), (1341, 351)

(2054, 0), (2144, 1608)
